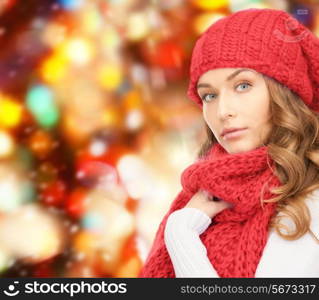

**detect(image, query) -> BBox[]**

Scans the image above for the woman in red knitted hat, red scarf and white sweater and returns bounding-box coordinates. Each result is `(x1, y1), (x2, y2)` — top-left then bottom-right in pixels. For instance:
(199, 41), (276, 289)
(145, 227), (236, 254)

(139, 9), (319, 277)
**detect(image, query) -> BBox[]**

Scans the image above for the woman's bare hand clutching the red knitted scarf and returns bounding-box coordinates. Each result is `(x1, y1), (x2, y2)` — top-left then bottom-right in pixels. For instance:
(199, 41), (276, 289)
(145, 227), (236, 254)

(185, 190), (232, 218)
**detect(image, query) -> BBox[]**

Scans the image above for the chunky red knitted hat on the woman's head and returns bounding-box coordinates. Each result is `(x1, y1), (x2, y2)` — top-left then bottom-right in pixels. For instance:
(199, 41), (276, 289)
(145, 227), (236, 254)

(187, 8), (319, 111)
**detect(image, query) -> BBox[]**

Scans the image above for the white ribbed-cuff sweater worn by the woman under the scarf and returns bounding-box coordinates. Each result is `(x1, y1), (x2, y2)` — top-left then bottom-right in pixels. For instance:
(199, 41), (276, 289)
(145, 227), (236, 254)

(164, 189), (319, 278)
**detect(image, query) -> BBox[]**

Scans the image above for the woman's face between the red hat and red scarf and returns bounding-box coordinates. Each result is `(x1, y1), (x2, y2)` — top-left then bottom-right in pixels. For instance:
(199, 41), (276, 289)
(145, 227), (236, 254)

(197, 68), (271, 153)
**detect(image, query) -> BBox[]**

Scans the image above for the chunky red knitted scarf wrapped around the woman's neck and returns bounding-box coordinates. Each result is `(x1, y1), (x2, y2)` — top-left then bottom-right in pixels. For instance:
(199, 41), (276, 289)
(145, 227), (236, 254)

(139, 143), (280, 278)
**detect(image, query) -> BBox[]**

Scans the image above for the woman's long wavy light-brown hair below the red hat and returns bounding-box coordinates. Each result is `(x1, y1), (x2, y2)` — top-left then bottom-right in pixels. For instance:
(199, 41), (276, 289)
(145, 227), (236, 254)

(197, 75), (319, 240)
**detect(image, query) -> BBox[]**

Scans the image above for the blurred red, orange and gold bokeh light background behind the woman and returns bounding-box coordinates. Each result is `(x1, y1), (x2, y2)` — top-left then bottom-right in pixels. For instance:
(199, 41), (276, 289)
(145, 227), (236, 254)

(0, 0), (319, 277)
